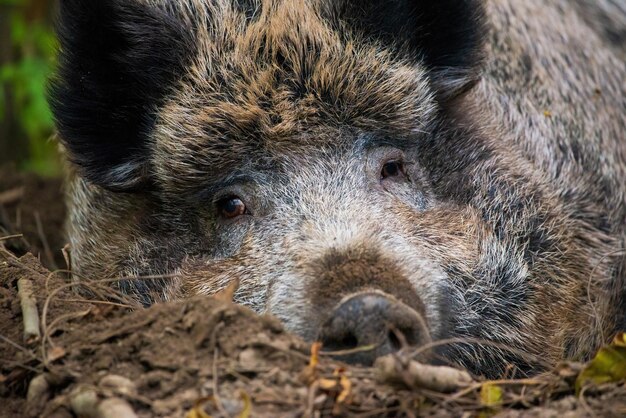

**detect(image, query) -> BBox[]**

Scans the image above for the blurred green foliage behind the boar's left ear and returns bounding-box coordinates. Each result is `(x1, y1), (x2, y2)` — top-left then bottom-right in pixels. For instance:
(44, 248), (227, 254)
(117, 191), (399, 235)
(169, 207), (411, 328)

(0, 0), (60, 175)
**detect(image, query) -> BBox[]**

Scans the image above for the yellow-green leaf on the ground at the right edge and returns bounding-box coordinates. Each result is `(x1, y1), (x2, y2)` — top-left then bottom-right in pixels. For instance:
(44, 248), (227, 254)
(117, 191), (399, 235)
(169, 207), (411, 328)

(576, 332), (626, 394)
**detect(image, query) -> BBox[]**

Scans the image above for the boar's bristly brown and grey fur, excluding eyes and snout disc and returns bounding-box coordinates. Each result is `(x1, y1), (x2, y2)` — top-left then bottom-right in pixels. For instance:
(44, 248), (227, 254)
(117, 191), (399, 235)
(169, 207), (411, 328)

(52, 0), (626, 377)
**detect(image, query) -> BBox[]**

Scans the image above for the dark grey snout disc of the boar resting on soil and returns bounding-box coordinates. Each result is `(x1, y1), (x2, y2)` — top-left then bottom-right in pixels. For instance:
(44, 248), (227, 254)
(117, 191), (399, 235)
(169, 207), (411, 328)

(319, 291), (430, 365)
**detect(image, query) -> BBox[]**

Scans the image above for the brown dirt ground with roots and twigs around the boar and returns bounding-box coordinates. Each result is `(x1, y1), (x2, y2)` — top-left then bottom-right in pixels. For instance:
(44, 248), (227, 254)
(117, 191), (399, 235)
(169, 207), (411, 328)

(0, 168), (626, 418)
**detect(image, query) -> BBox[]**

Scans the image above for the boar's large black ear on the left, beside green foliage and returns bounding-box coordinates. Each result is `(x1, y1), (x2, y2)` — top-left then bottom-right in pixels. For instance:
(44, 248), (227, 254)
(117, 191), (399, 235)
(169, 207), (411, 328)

(49, 0), (193, 191)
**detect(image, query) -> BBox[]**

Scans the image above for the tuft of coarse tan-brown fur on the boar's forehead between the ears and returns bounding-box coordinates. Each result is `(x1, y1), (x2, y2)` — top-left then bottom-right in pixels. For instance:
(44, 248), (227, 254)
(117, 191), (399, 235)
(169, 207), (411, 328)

(153, 1), (435, 193)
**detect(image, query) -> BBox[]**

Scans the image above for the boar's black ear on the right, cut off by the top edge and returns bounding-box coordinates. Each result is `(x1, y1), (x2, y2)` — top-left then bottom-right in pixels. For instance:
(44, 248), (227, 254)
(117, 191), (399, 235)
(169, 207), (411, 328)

(325, 0), (487, 100)
